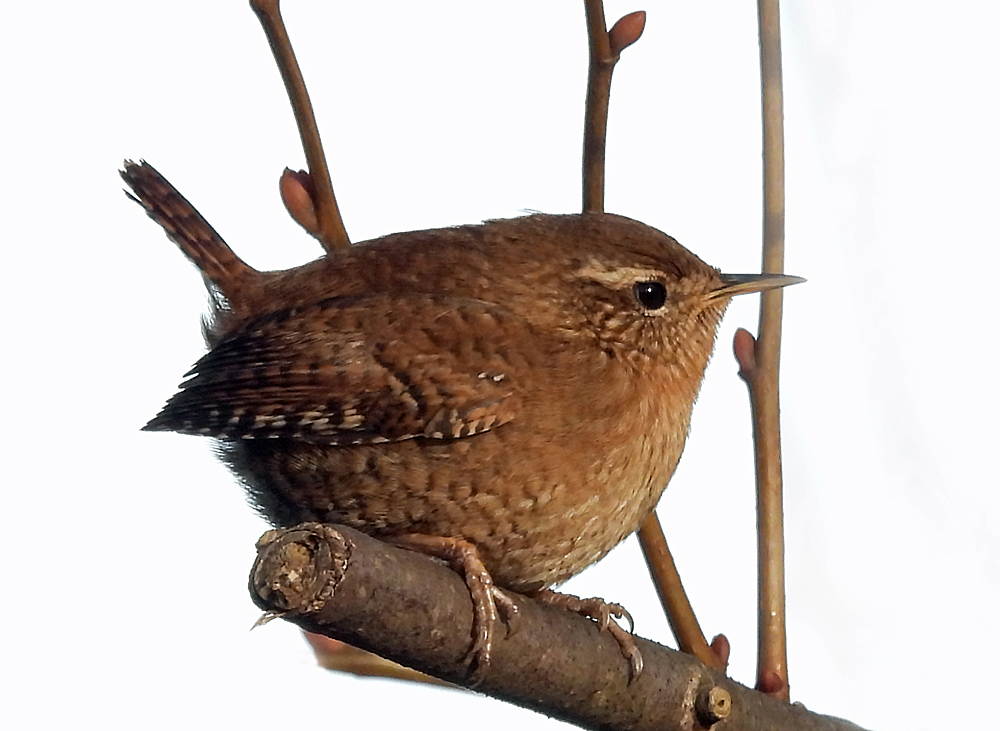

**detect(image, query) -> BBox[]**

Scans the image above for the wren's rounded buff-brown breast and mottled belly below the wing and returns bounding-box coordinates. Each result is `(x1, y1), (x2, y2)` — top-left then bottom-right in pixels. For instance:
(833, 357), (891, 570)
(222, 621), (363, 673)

(225, 354), (687, 590)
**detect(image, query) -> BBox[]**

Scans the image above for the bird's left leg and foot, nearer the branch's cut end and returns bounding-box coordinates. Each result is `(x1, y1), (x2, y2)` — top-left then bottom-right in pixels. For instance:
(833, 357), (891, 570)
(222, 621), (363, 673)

(389, 533), (518, 685)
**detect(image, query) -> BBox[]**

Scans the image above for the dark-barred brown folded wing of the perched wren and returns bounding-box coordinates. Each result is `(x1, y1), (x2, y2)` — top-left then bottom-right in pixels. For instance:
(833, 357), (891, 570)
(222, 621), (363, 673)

(145, 294), (528, 444)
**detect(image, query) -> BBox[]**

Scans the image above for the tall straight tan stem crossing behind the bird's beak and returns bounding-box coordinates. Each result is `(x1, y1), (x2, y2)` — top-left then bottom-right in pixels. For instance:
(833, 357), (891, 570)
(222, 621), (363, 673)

(748, 0), (788, 699)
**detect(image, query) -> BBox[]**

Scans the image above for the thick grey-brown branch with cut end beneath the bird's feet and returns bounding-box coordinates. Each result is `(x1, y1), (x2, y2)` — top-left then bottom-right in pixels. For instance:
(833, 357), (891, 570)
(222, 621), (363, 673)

(250, 523), (856, 731)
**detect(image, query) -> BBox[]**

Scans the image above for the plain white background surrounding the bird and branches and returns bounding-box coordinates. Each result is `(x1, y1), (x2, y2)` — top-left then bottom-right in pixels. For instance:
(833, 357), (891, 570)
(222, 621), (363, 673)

(0, 0), (1000, 729)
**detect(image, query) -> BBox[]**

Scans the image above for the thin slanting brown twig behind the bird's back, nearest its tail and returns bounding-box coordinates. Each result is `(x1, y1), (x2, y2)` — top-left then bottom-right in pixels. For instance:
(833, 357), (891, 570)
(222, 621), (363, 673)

(250, 0), (351, 252)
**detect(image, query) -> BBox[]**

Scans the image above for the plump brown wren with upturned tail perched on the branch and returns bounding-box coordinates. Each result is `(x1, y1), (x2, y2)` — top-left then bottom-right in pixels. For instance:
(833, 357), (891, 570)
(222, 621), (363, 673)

(122, 162), (801, 666)
